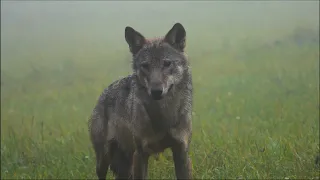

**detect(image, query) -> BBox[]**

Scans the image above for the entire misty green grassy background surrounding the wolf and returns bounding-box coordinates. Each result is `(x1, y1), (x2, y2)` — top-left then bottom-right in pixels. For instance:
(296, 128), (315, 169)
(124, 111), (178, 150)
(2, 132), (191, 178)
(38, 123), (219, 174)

(1, 1), (319, 179)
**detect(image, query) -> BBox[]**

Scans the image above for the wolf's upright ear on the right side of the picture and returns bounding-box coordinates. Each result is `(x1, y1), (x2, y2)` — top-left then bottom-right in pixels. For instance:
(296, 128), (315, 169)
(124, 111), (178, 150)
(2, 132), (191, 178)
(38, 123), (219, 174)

(164, 23), (186, 52)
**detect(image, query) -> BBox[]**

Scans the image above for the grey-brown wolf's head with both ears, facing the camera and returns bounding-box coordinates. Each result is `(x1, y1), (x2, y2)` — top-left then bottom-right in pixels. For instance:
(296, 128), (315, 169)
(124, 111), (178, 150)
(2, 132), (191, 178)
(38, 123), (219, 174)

(125, 23), (188, 100)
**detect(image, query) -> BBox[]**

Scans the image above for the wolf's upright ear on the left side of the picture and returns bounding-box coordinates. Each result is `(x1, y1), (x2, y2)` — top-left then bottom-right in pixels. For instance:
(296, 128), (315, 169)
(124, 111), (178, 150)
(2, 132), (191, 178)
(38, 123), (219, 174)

(125, 26), (146, 54)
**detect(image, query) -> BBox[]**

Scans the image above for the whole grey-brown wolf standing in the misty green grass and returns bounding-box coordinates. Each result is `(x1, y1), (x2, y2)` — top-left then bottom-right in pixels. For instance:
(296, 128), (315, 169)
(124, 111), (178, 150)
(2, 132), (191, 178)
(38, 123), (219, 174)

(88, 23), (193, 179)
